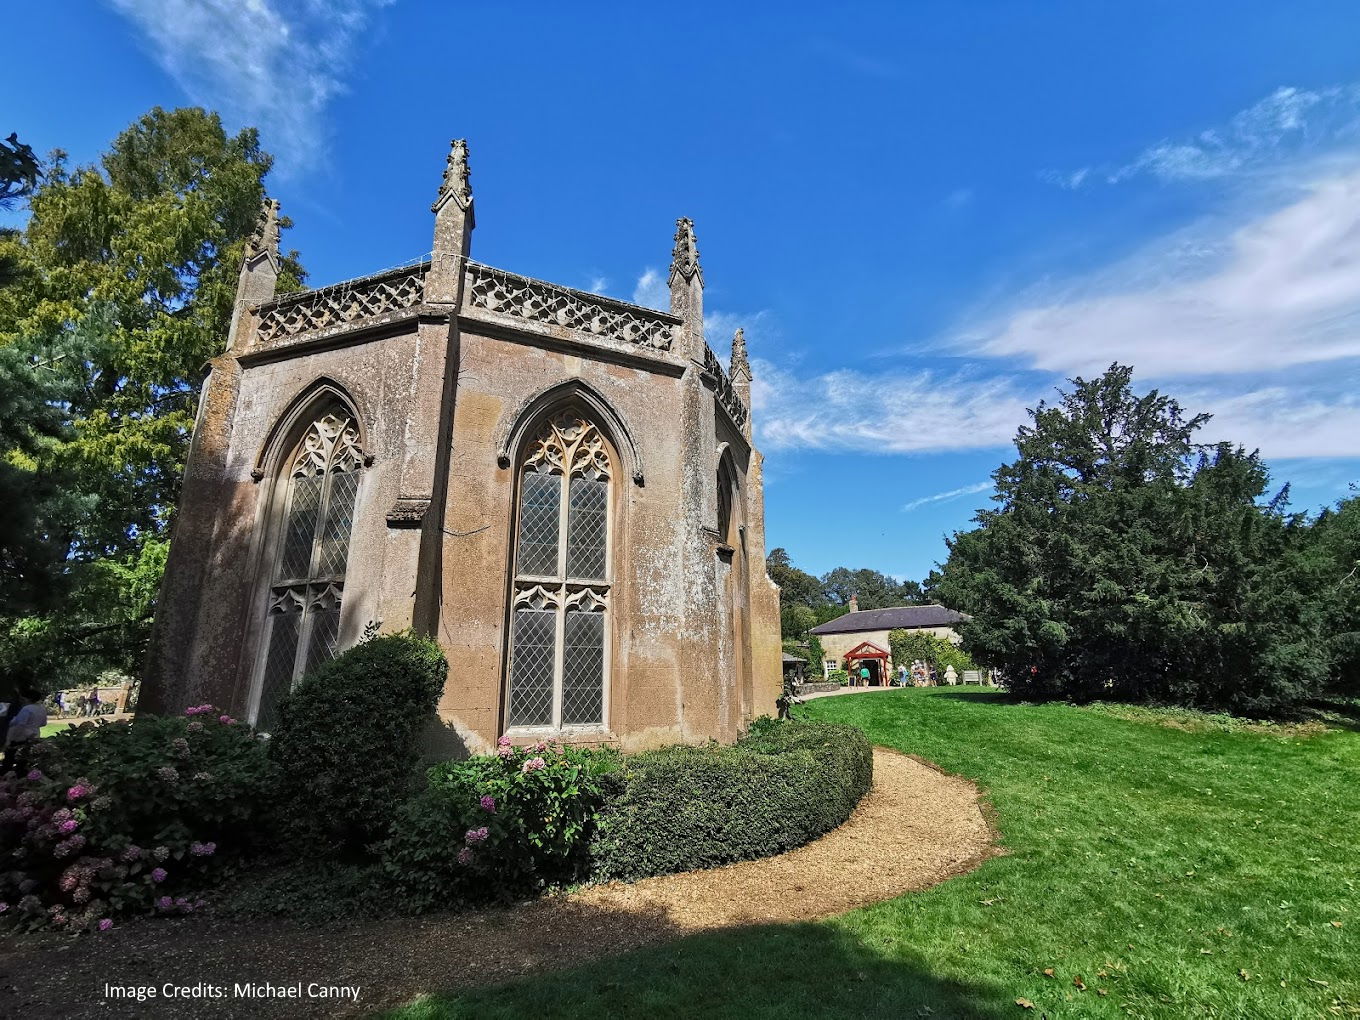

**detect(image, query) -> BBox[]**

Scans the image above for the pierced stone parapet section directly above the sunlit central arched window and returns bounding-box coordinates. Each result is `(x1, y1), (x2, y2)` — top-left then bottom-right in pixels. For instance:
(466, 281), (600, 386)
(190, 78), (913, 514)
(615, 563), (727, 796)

(464, 262), (677, 351)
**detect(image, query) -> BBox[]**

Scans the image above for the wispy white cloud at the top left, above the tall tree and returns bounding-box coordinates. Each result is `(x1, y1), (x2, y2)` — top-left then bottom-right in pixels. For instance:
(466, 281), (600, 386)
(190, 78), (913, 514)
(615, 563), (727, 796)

(106, 0), (392, 175)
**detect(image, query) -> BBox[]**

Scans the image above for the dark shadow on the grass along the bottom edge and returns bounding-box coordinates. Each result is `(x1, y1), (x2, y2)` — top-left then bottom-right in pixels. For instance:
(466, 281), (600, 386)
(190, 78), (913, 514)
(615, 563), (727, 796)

(389, 923), (1019, 1020)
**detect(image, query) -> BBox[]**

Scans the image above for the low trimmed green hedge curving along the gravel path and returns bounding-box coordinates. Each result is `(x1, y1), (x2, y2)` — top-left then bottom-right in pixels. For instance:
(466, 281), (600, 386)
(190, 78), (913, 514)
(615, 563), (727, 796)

(590, 722), (873, 879)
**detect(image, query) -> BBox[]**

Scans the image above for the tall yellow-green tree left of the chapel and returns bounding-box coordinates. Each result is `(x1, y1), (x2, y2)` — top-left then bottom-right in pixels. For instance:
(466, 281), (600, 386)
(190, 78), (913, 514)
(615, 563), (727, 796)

(0, 107), (303, 684)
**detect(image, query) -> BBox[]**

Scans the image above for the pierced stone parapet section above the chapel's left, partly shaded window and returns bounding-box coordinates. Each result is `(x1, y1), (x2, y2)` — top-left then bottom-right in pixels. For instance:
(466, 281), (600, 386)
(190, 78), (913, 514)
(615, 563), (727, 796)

(254, 262), (430, 344)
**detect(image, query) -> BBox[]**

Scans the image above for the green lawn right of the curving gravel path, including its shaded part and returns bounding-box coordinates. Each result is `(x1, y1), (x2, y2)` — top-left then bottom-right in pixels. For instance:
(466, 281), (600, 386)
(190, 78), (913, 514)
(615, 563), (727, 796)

(388, 690), (1360, 1020)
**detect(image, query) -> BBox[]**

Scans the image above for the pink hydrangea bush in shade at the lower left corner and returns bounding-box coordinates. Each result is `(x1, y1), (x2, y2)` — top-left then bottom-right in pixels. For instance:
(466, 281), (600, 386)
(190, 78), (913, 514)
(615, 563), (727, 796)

(0, 706), (271, 930)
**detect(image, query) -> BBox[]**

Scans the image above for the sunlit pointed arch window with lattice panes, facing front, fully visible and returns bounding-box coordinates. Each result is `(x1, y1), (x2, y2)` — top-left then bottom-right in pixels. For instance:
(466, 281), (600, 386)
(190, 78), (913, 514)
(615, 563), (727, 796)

(506, 412), (615, 729)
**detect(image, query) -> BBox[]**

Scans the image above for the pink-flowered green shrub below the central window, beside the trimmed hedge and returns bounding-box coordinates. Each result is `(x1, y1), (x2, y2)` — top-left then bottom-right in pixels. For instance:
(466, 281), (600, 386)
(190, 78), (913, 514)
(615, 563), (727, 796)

(381, 737), (619, 911)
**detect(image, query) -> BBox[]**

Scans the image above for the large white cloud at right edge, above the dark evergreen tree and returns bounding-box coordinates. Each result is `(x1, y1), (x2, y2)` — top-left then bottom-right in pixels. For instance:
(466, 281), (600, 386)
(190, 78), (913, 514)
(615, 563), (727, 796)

(962, 171), (1360, 378)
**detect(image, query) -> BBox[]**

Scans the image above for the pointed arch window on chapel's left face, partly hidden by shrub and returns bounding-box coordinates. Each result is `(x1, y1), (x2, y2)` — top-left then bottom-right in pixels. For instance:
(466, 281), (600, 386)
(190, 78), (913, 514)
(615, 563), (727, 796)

(254, 407), (363, 732)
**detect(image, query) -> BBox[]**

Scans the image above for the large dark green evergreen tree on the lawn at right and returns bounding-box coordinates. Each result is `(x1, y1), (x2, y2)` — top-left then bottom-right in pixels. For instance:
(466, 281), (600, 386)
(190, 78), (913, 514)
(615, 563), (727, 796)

(937, 364), (1329, 713)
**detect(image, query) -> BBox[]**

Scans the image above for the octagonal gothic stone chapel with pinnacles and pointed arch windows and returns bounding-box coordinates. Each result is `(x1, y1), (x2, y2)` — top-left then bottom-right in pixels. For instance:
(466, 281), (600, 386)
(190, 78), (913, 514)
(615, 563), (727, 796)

(141, 140), (781, 752)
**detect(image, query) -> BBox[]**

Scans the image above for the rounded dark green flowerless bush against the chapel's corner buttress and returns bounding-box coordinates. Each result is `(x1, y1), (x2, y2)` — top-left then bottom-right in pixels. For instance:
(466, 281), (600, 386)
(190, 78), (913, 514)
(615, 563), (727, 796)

(269, 634), (449, 853)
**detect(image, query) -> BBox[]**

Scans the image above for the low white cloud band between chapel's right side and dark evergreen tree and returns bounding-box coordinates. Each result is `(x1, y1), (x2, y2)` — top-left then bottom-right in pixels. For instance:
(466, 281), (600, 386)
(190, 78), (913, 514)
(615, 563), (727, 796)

(751, 359), (1038, 453)
